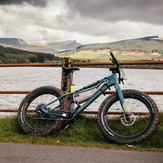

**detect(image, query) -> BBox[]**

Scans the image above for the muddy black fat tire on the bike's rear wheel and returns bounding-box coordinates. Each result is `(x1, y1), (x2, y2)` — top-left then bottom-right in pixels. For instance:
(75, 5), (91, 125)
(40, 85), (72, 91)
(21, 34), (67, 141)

(17, 86), (67, 136)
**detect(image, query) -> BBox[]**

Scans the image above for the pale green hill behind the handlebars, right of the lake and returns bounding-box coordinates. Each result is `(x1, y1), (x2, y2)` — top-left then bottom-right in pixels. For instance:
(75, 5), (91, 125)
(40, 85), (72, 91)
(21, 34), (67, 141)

(57, 36), (163, 61)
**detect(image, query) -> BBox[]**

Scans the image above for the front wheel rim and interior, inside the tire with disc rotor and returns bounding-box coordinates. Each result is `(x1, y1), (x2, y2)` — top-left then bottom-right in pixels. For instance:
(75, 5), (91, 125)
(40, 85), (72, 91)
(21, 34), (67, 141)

(104, 95), (153, 139)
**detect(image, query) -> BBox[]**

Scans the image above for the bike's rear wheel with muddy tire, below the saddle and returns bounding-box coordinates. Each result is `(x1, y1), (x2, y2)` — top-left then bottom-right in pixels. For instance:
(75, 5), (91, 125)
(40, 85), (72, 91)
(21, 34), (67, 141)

(18, 86), (66, 135)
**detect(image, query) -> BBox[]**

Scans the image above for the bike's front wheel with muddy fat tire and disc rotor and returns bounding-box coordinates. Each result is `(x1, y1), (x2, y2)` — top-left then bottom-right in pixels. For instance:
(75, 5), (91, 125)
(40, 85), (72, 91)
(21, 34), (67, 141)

(98, 90), (159, 144)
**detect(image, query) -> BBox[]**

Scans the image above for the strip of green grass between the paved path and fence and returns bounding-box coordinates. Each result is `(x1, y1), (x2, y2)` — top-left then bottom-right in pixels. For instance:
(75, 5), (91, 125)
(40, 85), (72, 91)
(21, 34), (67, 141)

(0, 114), (163, 151)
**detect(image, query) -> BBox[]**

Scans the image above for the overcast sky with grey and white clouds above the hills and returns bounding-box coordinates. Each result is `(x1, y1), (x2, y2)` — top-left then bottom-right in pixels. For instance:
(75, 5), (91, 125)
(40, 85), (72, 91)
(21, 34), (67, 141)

(0, 0), (163, 44)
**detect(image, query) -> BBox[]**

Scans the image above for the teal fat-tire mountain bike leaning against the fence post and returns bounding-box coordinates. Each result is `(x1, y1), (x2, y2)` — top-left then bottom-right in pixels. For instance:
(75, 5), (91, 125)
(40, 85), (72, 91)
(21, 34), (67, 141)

(18, 52), (159, 144)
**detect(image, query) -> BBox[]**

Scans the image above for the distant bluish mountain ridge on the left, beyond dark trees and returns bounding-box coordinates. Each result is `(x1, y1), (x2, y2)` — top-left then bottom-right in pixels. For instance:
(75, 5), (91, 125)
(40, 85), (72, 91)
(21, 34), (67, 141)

(0, 38), (81, 54)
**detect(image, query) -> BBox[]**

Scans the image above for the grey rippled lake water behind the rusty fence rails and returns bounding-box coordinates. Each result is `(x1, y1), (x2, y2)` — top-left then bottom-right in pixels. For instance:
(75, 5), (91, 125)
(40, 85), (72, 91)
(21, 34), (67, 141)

(0, 67), (163, 114)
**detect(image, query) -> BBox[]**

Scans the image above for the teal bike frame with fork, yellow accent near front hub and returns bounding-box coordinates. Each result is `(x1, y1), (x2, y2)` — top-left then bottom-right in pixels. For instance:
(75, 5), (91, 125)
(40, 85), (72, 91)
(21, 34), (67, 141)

(41, 73), (127, 119)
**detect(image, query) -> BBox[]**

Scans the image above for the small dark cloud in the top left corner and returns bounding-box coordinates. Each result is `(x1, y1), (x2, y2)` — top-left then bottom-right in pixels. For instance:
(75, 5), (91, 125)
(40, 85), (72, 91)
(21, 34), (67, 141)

(0, 0), (47, 7)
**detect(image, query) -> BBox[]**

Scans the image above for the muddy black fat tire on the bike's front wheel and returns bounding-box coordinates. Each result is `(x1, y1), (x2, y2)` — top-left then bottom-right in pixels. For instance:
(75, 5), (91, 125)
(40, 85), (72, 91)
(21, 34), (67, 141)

(97, 89), (159, 144)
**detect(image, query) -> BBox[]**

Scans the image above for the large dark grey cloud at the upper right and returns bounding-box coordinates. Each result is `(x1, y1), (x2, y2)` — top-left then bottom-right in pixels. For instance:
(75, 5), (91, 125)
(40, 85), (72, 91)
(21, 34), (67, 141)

(67, 0), (163, 24)
